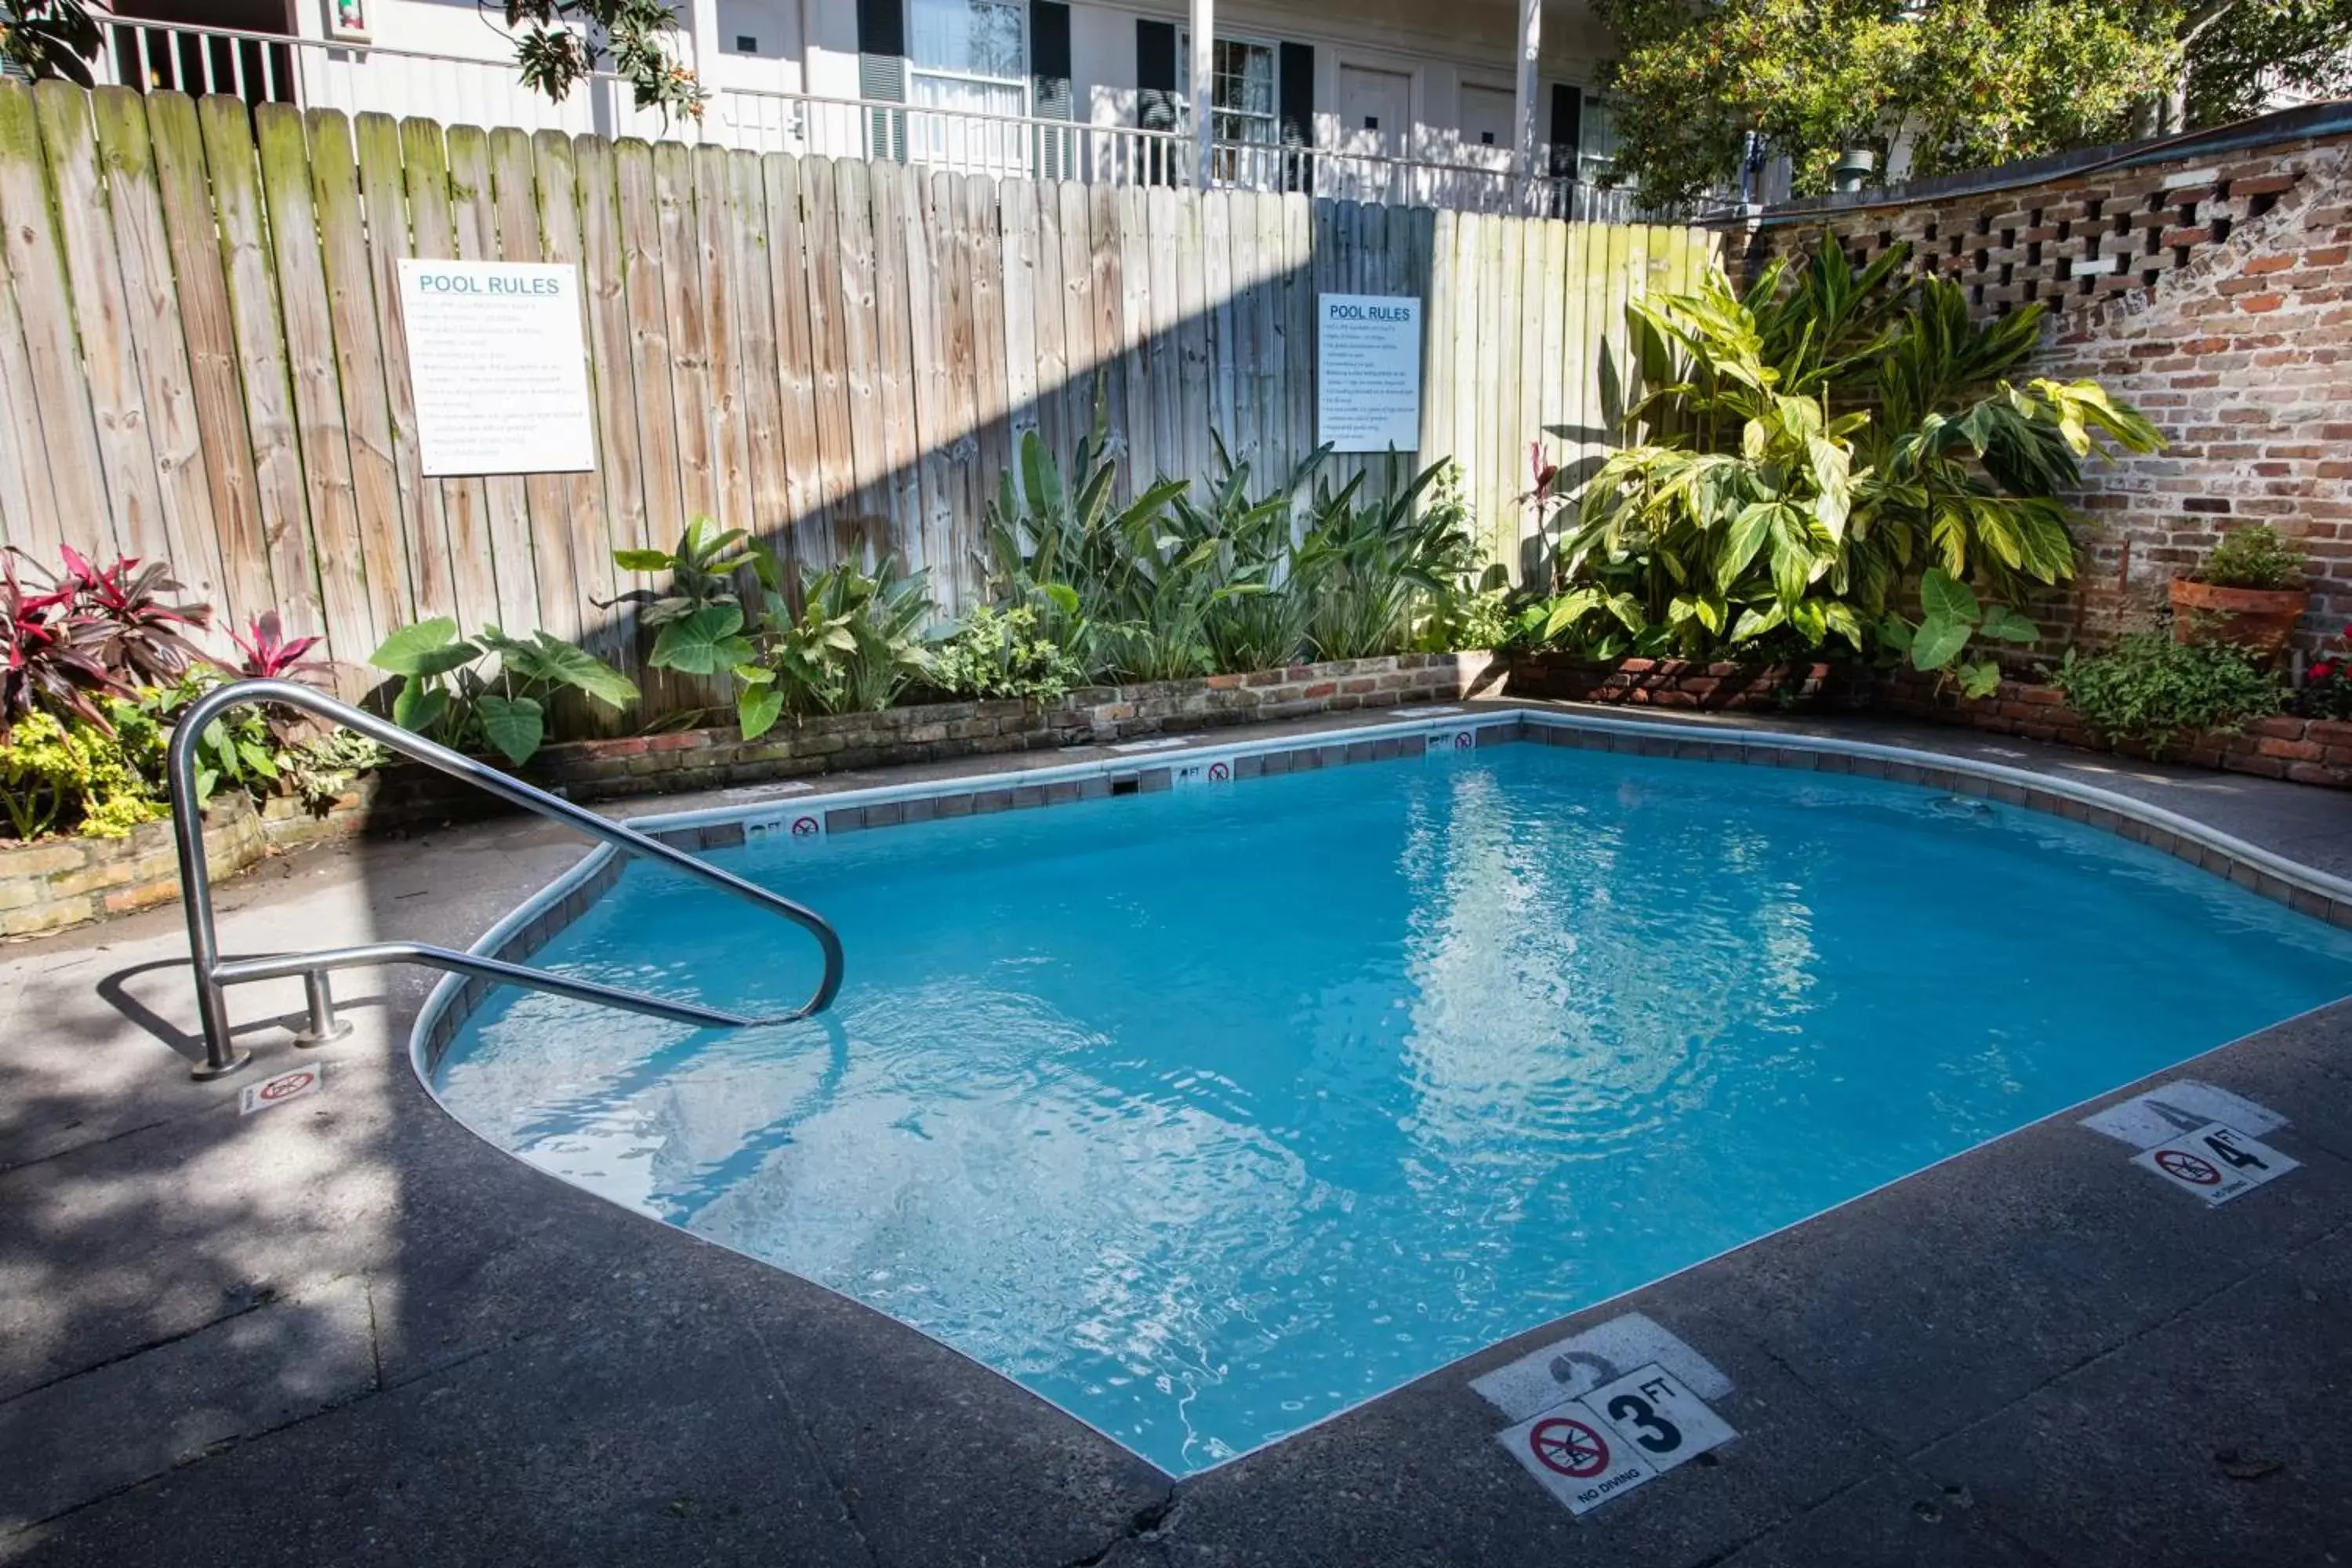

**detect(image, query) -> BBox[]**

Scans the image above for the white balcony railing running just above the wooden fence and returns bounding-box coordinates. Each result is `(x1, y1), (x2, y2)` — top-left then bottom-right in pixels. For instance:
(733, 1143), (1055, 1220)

(82, 19), (1651, 221)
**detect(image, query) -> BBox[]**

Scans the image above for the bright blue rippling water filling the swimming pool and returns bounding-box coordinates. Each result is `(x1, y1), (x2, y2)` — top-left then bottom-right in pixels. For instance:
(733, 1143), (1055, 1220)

(440, 746), (2352, 1474)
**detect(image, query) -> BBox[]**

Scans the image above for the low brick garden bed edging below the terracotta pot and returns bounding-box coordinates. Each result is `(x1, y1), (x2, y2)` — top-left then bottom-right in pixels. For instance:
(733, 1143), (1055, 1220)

(1879, 670), (2352, 789)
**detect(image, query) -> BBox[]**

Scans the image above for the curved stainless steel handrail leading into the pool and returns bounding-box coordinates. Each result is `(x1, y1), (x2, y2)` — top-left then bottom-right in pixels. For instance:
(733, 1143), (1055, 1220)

(169, 680), (842, 1079)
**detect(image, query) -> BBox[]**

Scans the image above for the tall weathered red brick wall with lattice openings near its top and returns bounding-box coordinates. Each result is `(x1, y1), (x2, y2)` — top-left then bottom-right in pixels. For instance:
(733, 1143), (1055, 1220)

(1750, 118), (2352, 649)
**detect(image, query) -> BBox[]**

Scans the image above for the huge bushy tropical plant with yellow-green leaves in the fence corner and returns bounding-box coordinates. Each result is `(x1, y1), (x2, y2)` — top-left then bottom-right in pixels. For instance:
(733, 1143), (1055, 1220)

(1543, 242), (2157, 656)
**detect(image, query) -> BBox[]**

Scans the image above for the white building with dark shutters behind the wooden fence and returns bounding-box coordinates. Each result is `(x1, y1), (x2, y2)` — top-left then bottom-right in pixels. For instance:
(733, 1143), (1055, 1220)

(101, 0), (1630, 216)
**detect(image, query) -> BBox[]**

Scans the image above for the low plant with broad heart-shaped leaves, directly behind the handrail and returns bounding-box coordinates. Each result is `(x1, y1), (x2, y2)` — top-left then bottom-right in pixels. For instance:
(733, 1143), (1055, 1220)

(367, 616), (637, 767)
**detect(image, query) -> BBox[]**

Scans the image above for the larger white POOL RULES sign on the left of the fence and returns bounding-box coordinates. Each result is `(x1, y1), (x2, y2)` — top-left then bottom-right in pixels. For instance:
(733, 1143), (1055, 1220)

(400, 259), (595, 477)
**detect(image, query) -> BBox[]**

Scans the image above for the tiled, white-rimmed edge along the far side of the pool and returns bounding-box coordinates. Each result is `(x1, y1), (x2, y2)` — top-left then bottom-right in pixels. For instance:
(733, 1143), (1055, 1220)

(409, 703), (2352, 1091)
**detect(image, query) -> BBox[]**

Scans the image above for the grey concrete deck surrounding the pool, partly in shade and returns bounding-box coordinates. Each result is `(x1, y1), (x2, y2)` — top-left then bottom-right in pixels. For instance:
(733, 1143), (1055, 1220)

(0, 703), (2352, 1568)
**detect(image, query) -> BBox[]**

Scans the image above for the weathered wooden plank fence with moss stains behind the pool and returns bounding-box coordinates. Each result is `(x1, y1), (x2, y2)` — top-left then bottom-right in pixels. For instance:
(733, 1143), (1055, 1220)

(0, 82), (1715, 705)
